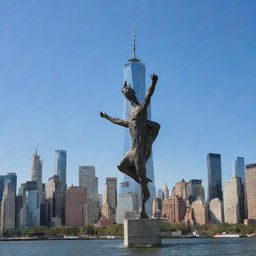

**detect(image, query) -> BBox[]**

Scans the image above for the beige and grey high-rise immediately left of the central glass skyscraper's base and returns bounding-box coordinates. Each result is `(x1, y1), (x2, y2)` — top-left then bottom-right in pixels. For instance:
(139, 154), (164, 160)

(102, 177), (117, 222)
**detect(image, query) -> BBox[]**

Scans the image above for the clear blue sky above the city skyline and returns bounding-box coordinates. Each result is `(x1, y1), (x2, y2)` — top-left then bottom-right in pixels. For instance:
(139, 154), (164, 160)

(0, 0), (256, 193)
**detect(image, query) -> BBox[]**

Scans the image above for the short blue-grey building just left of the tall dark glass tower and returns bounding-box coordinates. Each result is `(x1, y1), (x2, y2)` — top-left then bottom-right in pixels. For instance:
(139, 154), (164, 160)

(187, 179), (205, 204)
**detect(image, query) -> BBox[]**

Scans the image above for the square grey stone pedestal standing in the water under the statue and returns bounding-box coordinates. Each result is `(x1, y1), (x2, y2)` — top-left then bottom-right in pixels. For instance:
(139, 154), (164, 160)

(124, 219), (161, 247)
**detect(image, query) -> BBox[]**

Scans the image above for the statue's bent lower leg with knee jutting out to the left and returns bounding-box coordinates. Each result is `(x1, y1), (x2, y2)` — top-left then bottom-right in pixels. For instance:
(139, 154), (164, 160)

(117, 152), (140, 183)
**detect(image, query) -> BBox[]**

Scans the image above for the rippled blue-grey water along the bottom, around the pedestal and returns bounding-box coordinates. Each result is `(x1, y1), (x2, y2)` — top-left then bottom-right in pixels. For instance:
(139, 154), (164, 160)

(0, 238), (256, 256)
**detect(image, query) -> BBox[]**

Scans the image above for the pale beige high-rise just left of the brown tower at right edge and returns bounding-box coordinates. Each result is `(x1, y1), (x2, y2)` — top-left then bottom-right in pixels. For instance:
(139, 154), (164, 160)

(224, 177), (244, 224)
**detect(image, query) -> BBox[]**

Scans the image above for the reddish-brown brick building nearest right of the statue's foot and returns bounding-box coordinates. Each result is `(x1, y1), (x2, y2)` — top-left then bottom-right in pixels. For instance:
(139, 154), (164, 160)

(162, 196), (186, 223)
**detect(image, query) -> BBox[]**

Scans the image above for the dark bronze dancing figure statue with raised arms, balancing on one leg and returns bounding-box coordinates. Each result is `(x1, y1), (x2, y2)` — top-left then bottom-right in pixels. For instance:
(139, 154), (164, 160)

(100, 74), (160, 219)
